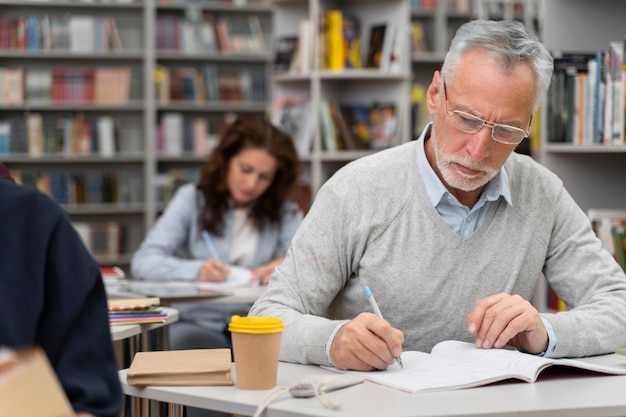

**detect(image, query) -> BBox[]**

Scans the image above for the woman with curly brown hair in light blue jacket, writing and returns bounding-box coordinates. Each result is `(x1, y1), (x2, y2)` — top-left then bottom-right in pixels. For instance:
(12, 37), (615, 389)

(131, 116), (303, 349)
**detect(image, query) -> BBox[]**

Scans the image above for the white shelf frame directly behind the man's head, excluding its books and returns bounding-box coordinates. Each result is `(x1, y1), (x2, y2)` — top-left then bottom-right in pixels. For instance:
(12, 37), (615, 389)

(271, 0), (411, 194)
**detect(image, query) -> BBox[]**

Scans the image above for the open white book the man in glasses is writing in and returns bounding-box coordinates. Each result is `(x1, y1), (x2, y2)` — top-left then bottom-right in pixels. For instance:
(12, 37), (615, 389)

(324, 340), (626, 393)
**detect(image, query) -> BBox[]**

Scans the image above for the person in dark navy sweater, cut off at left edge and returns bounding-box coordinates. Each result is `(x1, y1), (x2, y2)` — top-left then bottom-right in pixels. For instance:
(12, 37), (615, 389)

(0, 179), (123, 417)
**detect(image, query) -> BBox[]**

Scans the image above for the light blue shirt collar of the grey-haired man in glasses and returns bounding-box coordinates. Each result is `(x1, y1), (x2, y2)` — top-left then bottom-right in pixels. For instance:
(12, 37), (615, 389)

(417, 123), (513, 207)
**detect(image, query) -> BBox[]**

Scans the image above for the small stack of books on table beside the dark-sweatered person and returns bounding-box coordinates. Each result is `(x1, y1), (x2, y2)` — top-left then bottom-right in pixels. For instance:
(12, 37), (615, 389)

(109, 297), (167, 325)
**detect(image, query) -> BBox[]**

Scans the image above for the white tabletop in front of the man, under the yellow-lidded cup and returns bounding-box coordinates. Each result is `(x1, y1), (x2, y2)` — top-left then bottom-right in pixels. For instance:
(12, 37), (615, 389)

(119, 363), (626, 417)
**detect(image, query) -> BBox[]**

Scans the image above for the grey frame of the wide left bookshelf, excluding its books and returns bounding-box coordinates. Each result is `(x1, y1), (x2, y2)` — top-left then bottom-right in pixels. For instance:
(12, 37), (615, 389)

(0, 0), (273, 270)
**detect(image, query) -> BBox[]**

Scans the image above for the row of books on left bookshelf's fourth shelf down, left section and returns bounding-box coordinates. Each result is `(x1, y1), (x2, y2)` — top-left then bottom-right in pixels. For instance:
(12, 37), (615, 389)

(11, 169), (140, 205)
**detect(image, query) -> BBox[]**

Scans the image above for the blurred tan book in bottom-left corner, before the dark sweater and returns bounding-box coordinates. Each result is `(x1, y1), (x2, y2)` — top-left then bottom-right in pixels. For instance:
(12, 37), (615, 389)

(0, 347), (74, 417)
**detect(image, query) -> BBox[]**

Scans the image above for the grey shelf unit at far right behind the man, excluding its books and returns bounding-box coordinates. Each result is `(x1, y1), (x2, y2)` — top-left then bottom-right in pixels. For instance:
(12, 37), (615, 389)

(538, 0), (626, 210)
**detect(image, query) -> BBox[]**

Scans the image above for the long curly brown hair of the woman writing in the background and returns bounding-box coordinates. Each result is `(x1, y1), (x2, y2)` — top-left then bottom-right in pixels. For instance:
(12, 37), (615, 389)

(196, 116), (300, 236)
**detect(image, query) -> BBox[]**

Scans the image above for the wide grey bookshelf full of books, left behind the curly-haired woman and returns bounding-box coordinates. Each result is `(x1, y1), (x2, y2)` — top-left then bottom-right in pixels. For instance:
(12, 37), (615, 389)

(0, 0), (273, 269)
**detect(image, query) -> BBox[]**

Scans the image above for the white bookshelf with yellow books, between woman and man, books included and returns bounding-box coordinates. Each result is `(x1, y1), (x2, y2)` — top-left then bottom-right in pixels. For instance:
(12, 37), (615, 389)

(271, 0), (411, 197)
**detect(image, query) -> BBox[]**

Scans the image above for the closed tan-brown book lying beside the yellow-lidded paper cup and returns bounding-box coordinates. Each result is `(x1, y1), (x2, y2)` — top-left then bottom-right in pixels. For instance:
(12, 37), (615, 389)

(126, 348), (234, 386)
